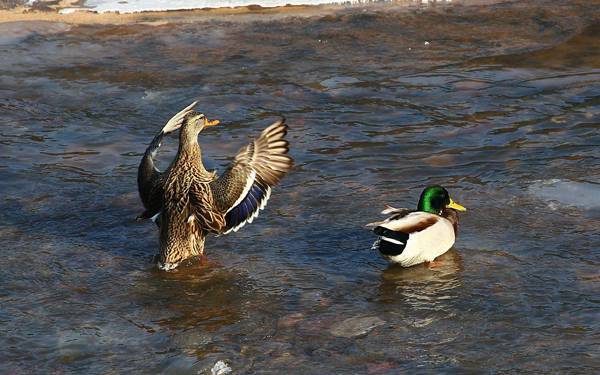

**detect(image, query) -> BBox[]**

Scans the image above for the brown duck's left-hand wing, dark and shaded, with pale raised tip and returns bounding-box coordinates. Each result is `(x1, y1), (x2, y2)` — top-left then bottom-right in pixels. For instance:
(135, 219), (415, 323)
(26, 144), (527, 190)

(138, 102), (198, 219)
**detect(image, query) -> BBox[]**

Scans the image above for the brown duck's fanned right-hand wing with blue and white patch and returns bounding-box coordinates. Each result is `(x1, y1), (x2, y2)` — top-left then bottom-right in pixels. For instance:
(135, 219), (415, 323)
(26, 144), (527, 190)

(210, 119), (293, 233)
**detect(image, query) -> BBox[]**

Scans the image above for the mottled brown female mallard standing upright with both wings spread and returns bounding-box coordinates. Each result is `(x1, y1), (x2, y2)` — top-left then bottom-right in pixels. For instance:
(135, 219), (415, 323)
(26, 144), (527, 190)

(138, 102), (292, 270)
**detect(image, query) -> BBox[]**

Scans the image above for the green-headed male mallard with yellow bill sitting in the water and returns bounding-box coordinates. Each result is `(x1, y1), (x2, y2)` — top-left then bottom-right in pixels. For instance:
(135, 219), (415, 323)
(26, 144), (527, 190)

(367, 185), (467, 267)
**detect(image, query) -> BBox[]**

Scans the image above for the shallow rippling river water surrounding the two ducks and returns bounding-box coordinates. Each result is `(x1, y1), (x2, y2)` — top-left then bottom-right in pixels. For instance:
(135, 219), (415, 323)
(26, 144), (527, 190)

(0, 2), (600, 374)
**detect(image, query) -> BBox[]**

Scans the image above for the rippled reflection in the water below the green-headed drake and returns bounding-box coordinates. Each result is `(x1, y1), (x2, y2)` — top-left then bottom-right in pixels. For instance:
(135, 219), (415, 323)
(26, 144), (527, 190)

(379, 249), (464, 309)
